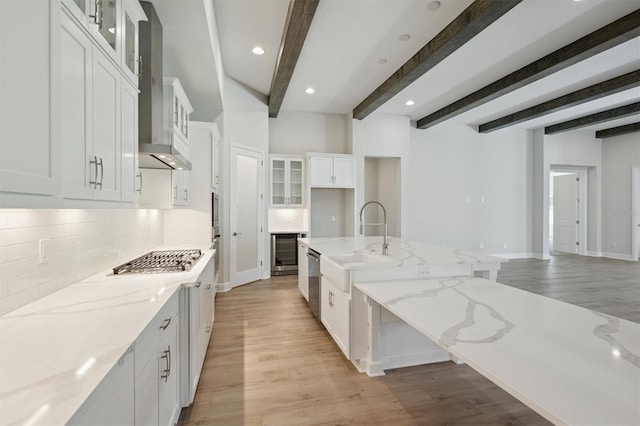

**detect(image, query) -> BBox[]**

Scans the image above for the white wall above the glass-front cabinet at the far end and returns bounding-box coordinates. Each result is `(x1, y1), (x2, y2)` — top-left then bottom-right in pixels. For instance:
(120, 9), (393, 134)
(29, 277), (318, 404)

(269, 111), (350, 155)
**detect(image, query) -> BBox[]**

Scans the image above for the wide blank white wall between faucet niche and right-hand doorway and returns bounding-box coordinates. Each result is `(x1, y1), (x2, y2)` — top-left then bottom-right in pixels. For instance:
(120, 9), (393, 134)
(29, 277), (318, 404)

(403, 123), (532, 257)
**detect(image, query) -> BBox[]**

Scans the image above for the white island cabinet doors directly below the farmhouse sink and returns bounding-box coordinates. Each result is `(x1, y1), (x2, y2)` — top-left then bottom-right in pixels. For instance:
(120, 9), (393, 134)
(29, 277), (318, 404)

(320, 276), (351, 359)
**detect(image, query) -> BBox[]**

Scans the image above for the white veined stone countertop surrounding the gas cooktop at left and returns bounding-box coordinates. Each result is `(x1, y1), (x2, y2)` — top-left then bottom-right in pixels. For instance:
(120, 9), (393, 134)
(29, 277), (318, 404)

(0, 247), (215, 425)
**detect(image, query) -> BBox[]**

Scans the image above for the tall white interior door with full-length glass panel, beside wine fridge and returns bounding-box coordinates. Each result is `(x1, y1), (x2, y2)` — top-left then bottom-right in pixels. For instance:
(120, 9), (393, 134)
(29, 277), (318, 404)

(230, 146), (263, 286)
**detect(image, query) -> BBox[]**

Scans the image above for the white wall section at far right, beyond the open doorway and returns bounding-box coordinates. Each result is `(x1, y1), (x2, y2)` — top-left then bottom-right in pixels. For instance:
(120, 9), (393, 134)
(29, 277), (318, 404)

(602, 133), (640, 260)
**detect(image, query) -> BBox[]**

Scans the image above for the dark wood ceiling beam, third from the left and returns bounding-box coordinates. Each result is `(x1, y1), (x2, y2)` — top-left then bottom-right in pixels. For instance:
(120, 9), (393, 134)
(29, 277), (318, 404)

(417, 9), (640, 129)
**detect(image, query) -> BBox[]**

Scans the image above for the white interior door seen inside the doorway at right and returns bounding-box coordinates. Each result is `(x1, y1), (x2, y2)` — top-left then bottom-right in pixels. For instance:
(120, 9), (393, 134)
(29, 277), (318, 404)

(553, 174), (578, 253)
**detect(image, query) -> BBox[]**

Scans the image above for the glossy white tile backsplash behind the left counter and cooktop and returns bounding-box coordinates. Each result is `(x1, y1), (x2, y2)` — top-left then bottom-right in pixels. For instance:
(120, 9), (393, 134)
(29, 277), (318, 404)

(0, 209), (164, 315)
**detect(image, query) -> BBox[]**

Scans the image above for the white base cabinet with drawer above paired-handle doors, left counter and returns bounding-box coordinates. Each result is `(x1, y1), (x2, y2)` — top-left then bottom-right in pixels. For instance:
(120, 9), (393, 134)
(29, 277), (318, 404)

(134, 293), (180, 426)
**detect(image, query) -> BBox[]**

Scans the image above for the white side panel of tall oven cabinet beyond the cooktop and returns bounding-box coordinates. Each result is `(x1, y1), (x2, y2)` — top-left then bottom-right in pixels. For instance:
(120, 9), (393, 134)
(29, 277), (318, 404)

(164, 121), (213, 247)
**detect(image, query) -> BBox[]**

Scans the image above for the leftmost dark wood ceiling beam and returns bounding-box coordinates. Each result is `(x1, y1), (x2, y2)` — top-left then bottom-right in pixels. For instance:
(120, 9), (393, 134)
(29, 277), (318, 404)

(269, 0), (320, 118)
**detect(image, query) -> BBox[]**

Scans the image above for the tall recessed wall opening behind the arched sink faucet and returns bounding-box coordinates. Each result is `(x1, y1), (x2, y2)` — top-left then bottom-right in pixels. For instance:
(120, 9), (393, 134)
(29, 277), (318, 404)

(364, 157), (402, 237)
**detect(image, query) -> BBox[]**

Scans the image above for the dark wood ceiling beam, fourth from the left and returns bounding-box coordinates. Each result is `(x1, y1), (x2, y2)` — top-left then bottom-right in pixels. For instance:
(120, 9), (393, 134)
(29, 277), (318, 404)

(478, 70), (640, 133)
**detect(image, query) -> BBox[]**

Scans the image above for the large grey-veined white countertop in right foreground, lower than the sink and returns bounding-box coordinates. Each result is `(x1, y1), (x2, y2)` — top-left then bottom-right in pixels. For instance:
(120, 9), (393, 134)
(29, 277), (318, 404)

(354, 277), (640, 425)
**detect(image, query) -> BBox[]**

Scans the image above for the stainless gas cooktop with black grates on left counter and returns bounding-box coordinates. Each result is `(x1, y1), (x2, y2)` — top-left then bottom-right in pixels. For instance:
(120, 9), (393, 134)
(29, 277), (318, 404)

(113, 249), (202, 274)
